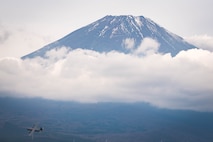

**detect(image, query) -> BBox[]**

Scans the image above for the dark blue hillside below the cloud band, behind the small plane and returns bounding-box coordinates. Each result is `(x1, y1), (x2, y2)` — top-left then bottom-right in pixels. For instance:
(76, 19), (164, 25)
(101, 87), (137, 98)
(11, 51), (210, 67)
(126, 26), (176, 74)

(0, 98), (213, 142)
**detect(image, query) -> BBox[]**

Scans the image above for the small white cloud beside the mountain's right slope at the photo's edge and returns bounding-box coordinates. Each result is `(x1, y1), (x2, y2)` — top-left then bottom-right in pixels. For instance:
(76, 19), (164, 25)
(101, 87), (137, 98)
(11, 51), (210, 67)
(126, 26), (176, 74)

(186, 35), (213, 51)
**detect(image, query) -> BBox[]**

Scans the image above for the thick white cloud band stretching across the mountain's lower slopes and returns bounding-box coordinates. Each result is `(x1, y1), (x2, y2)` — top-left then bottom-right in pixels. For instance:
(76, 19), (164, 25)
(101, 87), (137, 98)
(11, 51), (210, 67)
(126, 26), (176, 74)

(0, 40), (213, 111)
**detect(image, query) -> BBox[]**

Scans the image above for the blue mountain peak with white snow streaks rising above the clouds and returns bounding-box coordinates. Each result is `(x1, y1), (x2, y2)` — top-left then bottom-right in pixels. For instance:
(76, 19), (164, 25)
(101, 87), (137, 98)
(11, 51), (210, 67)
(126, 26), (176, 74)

(22, 15), (196, 59)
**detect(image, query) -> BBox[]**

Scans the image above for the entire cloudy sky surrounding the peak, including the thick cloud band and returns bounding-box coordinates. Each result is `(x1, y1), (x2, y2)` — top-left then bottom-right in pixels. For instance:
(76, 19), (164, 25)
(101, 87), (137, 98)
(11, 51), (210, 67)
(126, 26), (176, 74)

(0, 0), (213, 111)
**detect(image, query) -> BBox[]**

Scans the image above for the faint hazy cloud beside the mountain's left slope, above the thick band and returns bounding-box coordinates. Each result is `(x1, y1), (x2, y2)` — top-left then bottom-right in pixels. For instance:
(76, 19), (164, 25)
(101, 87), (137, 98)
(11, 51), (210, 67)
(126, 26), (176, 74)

(0, 24), (51, 58)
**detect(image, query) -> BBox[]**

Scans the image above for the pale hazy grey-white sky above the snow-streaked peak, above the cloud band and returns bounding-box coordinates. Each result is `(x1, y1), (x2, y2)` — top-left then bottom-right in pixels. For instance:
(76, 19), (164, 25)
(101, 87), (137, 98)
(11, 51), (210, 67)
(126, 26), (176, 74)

(0, 0), (213, 57)
